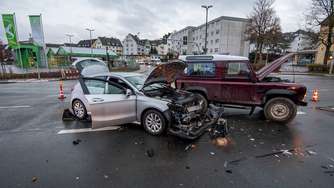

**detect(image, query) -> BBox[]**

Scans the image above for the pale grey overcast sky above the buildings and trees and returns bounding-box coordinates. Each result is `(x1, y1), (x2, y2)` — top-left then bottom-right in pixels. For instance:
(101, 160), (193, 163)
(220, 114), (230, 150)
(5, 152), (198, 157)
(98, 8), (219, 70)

(0, 0), (310, 43)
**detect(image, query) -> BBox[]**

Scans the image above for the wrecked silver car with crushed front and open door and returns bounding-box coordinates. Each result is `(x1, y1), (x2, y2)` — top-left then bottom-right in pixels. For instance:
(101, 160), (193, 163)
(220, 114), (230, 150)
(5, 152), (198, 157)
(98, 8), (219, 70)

(70, 62), (222, 139)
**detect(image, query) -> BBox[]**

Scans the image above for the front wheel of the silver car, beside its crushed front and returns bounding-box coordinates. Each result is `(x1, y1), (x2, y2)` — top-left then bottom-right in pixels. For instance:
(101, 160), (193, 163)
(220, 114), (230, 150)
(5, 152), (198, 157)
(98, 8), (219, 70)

(142, 110), (166, 135)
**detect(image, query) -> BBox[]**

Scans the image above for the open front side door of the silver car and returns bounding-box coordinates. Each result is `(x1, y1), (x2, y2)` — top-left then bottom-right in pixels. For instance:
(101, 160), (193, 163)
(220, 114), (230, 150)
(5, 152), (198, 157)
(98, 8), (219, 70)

(80, 78), (136, 128)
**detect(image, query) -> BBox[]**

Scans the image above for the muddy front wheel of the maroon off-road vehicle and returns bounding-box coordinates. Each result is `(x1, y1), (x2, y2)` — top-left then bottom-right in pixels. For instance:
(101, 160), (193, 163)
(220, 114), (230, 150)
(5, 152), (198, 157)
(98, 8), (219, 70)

(264, 97), (297, 123)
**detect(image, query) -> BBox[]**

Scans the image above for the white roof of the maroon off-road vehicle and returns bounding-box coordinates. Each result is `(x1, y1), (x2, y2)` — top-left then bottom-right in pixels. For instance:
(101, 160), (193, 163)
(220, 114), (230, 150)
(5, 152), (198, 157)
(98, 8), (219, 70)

(179, 54), (248, 61)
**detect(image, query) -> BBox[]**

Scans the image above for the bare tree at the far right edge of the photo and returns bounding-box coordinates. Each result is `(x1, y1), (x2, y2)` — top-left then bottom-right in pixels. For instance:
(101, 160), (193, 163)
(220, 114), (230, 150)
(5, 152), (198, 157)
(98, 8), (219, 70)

(306, 0), (334, 65)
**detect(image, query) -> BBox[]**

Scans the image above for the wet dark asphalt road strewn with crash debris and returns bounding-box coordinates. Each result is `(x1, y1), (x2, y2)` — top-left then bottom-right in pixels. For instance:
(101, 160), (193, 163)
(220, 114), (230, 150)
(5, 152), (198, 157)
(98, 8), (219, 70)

(0, 76), (334, 187)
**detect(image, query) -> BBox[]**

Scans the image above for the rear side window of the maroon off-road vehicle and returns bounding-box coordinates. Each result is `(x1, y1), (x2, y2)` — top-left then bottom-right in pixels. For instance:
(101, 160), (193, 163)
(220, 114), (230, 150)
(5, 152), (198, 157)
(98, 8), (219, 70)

(184, 62), (216, 76)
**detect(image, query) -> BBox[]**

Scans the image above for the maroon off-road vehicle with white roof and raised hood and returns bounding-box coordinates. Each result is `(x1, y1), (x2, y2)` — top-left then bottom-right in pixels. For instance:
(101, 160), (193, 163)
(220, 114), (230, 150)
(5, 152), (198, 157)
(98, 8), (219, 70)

(176, 54), (307, 123)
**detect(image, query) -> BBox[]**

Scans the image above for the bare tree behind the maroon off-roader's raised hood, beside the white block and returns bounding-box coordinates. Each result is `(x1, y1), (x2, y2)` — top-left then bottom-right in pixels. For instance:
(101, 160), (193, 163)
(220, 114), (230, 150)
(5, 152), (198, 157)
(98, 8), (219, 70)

(246, 0), (281, 63)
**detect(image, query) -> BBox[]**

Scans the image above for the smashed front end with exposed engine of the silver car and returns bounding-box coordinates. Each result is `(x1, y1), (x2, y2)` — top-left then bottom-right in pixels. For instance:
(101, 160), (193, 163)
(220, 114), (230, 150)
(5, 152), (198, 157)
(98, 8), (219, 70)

(144, 86), (222, 139)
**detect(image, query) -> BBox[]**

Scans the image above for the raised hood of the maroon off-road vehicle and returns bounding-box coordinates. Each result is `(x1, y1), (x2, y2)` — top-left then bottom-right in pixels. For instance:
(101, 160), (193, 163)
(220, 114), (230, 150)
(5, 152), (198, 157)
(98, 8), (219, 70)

(256, 53), (295, 81)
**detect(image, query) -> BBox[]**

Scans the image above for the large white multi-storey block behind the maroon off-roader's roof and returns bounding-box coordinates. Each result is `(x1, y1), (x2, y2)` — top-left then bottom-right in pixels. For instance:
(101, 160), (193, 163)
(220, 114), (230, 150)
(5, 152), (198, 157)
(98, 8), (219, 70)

(168, 16), (249, 56)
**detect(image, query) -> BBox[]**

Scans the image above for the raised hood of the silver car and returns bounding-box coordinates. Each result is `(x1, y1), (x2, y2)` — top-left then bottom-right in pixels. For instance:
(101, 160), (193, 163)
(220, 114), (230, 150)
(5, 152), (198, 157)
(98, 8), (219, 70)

(143, 61), (187, 88)
